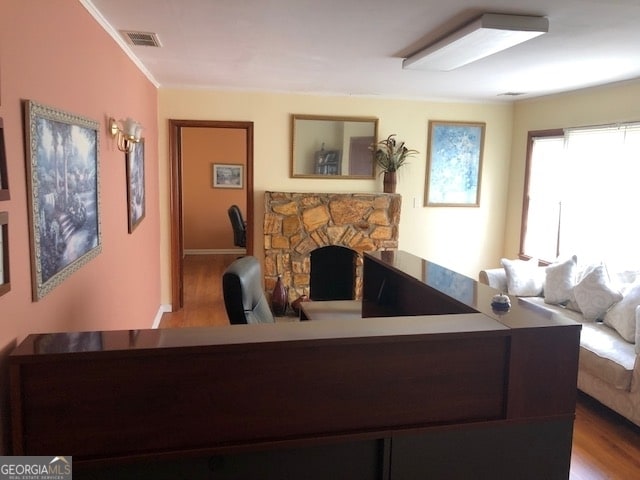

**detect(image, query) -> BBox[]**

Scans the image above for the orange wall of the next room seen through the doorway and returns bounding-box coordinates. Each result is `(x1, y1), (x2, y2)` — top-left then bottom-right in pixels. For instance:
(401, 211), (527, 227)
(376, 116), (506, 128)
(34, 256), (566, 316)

(182, 127), (247, 251)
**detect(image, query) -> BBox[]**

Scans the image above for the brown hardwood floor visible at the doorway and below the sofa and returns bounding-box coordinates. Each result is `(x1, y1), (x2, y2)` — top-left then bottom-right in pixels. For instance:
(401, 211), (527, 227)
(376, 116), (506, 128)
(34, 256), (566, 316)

(160, 255), (640, 480)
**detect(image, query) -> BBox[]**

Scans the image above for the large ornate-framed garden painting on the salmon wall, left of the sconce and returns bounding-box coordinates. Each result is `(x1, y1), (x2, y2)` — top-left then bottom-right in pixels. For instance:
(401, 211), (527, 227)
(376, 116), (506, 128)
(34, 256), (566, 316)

(24, 100), (102, 300)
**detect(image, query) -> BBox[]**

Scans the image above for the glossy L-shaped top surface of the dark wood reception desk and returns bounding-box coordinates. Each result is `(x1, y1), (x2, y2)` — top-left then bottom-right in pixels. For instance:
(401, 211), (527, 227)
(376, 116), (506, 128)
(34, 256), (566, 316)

(11, 251), (575, 357)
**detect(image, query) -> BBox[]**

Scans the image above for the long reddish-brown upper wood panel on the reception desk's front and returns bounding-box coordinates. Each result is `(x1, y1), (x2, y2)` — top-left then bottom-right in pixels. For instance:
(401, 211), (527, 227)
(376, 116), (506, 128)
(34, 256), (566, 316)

(15, 332), (508, 459)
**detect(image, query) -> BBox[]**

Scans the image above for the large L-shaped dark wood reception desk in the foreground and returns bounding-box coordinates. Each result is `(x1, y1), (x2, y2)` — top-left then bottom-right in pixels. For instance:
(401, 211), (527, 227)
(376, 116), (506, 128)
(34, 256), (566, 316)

(10, 252), (579, 479)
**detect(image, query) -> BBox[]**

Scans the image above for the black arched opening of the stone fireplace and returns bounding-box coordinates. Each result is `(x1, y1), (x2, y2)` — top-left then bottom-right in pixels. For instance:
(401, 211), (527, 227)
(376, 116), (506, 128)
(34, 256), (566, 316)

(309, 245), (358, 300)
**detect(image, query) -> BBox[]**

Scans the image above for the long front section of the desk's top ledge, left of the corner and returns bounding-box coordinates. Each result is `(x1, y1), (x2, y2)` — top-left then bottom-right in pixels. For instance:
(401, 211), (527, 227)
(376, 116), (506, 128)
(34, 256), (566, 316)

(11, 313), (508, 361)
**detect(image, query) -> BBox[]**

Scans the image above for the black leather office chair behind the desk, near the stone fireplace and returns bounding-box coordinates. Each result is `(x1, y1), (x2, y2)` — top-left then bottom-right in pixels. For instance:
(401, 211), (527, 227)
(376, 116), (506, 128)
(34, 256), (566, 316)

(222, 256), (275, 325)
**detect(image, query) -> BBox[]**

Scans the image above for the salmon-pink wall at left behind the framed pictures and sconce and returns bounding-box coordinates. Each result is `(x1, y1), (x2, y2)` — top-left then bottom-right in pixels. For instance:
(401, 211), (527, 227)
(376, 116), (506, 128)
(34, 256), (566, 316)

(0, 0), (160, 346)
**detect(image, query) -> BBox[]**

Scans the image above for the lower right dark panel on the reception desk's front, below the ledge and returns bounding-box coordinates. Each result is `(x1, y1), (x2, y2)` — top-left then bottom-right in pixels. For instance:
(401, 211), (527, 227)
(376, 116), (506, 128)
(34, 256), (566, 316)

(391, 418), (573, 480)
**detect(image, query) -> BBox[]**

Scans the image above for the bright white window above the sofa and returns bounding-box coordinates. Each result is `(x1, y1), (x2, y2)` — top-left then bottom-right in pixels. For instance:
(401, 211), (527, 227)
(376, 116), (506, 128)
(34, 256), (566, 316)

(520, 124), (640, 268)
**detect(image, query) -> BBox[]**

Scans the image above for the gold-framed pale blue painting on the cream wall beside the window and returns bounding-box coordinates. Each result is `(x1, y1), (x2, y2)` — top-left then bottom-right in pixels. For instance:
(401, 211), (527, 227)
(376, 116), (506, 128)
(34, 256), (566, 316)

(424, 121), (485, 207)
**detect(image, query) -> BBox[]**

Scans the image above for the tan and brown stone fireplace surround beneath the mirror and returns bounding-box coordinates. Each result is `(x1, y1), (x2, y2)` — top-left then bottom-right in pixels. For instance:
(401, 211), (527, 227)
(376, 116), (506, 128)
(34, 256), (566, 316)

(264, 192), (401, 301)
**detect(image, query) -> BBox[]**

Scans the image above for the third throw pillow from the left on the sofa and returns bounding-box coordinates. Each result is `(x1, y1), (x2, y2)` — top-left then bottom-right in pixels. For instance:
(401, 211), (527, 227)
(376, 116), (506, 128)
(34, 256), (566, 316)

(573, 265), (622, 321)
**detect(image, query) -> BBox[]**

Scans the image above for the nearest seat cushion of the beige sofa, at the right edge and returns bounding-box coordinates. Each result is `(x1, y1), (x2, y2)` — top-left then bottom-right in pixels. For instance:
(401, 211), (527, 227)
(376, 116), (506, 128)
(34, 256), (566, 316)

(580, 322), (636, 391)
